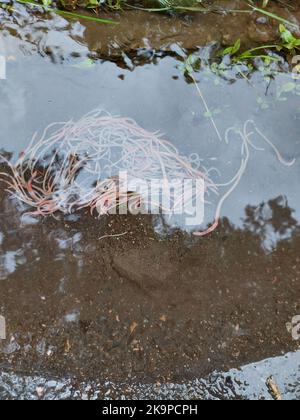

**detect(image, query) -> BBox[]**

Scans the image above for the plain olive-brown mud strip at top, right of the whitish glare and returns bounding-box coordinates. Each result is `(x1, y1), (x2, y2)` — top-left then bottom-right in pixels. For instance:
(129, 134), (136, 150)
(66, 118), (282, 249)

(62, 0), (300, 53)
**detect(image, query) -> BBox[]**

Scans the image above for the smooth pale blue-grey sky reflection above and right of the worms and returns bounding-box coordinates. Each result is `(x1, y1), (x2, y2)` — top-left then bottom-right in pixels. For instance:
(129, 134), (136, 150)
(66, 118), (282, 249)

(0, 49), (300, 236)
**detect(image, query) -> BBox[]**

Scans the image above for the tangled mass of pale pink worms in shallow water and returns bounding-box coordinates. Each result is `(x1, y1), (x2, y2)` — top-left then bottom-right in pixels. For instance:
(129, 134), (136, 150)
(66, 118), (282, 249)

(0, 110), (294, 236)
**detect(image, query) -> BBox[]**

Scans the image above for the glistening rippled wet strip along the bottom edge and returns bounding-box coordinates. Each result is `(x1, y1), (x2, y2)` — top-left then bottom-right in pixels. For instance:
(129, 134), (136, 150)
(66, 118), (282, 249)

(0, 352), (300, 400)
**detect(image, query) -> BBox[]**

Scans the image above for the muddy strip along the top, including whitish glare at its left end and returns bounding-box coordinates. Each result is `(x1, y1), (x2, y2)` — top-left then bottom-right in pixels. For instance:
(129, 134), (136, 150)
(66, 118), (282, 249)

(0, 0), (300, 62)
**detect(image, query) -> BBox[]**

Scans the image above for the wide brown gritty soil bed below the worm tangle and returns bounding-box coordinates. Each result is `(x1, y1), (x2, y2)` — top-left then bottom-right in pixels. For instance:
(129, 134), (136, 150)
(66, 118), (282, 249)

(0, 185), (300, 382)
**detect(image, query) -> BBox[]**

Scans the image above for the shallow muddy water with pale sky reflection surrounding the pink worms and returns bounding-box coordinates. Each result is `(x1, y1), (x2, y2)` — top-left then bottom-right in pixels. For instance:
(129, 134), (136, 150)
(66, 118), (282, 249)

(0, 2), (300, 398)
